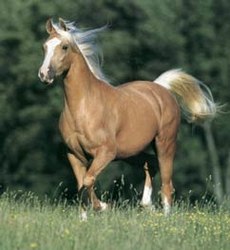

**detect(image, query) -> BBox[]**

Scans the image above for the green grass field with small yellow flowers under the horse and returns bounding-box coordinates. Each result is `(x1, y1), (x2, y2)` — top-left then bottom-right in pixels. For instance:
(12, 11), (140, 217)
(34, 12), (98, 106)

(0, 194), (230, 250)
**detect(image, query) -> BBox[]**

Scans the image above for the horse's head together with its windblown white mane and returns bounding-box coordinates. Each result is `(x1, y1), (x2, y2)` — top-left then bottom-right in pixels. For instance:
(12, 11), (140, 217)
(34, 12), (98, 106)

(38, 18), (106, 83)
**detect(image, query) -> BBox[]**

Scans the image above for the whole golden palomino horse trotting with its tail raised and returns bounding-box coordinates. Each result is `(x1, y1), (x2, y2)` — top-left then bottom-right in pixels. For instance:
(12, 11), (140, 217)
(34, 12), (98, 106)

(39, 19), (216, 219)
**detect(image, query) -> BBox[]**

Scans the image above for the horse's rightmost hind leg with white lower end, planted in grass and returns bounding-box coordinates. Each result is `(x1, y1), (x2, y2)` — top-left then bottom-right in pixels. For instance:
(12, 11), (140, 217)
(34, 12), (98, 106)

(156, 137), (176, 215)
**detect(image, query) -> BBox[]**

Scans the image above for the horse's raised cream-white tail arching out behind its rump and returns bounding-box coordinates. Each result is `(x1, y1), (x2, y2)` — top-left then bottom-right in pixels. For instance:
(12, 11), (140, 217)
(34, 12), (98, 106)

(154, 69), (218, 123)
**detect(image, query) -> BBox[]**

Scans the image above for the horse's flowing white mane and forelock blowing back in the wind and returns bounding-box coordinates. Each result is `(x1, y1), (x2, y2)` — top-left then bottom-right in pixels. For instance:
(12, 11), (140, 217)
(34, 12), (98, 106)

(52, 21), (108, 82)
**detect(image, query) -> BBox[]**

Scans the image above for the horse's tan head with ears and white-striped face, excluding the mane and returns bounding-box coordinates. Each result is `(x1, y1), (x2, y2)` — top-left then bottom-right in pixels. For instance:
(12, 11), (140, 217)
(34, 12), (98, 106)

(38, 19), (74, 83)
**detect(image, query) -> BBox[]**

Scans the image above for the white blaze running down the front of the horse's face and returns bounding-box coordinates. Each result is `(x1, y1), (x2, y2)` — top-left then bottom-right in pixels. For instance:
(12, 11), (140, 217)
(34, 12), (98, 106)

(40, 37), (61, 76)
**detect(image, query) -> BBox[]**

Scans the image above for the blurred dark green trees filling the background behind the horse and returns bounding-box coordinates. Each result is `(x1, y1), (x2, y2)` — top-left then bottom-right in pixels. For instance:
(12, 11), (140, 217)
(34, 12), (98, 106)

(0, 0), (230, 202)
